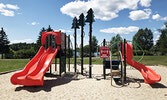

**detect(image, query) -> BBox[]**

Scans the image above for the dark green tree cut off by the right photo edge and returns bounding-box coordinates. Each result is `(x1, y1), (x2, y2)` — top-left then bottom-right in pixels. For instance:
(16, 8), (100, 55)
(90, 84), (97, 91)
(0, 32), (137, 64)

(156, 23), (167, 55)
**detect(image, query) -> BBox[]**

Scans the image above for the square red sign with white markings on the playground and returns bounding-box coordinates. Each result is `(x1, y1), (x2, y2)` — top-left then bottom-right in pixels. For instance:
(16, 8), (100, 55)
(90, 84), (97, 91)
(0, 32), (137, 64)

(100, 47), (110, 58)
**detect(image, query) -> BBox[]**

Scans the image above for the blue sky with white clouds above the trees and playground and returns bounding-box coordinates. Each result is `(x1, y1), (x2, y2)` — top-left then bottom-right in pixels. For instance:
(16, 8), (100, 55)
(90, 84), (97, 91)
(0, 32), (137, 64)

(0, 0), (167, 46)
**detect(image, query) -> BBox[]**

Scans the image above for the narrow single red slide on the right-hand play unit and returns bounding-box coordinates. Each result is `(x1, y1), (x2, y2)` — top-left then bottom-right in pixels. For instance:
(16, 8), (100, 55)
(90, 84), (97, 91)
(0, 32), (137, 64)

(123, 43), (161, 84)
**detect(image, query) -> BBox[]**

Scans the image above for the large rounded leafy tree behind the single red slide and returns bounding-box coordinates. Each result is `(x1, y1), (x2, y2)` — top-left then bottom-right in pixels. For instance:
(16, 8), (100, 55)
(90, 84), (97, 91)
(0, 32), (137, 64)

(133, 28), (153, 51)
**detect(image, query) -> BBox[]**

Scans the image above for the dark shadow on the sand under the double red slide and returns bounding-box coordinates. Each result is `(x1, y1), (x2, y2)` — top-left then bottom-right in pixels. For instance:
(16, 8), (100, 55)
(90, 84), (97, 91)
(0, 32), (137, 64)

(15, 73), (79, 92)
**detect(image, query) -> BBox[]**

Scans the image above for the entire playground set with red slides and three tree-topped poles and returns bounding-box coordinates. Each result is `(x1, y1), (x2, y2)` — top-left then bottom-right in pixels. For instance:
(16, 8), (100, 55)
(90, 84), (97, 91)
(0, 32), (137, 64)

(11, 9), (161, 86)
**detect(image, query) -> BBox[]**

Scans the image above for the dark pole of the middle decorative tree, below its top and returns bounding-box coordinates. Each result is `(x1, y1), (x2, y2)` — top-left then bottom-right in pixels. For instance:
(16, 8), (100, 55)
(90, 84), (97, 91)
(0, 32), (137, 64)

(81, 25), (84, 75)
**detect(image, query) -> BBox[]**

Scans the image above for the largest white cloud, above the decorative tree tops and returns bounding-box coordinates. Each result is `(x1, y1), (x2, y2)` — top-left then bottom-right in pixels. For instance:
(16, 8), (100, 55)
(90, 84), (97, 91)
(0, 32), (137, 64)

(60, 0), (140, 21)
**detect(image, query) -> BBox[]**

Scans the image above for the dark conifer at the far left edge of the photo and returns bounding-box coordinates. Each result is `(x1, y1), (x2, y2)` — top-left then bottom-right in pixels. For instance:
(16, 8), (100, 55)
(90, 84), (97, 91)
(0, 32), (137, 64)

(0, 28), (10, 59)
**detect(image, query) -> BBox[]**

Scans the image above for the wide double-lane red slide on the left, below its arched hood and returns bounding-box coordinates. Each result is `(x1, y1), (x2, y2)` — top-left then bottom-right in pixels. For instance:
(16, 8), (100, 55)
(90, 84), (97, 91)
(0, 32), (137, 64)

(11, 46), (59, 86)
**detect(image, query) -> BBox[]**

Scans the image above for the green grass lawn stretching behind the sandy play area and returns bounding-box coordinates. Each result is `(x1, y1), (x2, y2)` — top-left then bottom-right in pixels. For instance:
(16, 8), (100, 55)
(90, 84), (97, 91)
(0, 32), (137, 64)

(0, 56), (167, 72)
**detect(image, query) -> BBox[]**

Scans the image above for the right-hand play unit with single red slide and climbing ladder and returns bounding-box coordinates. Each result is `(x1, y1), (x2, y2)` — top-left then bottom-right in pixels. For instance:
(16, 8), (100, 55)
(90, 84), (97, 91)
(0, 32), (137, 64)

(103, 39), (161, 85)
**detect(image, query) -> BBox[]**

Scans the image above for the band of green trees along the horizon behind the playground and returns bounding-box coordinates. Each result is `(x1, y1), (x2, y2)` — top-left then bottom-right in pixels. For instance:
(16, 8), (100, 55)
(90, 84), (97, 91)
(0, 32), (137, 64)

(0, 23), (167, 59)
